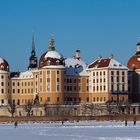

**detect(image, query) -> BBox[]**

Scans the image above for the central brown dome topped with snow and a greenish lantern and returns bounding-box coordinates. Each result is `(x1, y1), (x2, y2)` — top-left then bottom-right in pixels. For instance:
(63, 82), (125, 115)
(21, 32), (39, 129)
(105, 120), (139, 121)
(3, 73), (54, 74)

(39, 37), (64, 68)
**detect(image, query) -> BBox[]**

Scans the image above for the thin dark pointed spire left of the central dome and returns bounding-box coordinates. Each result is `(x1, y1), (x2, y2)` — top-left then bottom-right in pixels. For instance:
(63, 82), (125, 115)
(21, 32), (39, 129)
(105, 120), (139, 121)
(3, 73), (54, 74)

(28, 34), (37, 69)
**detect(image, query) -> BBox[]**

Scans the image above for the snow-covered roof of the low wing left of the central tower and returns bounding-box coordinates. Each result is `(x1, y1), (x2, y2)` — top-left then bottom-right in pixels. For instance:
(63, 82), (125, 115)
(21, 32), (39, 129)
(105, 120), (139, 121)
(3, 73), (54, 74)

(12, 71), (33, 79)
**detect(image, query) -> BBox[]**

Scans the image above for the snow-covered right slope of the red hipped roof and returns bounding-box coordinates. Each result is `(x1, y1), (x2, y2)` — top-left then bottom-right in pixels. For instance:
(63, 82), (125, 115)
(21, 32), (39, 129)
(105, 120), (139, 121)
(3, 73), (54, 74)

(108, 59), (128, 69)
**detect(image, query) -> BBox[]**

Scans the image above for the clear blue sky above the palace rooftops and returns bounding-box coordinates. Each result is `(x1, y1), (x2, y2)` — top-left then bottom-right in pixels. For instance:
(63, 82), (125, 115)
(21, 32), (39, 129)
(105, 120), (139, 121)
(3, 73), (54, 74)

(0, 0), (140, 71)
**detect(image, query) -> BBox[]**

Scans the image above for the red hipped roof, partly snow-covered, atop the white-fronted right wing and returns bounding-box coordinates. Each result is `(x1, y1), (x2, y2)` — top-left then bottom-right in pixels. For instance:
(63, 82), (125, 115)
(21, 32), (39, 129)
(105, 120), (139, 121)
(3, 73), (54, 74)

(88, 58), (127, 69)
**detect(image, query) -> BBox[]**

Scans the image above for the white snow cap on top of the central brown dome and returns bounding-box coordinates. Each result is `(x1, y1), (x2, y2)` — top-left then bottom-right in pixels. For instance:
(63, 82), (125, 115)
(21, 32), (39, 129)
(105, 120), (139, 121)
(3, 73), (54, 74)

(45, 51), (63, 59)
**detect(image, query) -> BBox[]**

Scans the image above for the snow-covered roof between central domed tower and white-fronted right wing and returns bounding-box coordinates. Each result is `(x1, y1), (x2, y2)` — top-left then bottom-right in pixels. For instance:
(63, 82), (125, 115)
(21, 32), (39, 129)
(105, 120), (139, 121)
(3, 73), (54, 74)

(65, 58), (87, 76)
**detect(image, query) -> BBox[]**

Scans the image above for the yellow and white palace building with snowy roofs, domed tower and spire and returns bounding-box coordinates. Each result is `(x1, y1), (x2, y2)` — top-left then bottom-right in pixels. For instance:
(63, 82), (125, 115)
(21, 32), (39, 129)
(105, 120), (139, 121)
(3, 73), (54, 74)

(0, 37), (128, 106)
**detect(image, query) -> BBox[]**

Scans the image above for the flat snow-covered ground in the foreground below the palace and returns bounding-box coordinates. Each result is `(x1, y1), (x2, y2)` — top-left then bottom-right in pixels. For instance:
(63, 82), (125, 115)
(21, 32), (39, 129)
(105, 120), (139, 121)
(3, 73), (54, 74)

(0, 121), (140, 140)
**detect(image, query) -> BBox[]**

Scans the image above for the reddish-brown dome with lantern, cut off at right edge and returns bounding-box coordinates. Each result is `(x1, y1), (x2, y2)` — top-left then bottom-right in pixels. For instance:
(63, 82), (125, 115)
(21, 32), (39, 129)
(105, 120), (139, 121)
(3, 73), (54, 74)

(127, 42), (140, 69)
